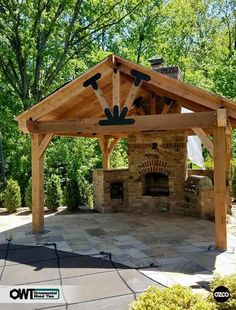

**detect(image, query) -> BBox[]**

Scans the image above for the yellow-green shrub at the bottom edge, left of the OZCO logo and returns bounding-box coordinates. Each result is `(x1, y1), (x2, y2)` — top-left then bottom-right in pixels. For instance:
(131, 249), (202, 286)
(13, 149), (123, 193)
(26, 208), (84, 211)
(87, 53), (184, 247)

(129, 285), (215, 310)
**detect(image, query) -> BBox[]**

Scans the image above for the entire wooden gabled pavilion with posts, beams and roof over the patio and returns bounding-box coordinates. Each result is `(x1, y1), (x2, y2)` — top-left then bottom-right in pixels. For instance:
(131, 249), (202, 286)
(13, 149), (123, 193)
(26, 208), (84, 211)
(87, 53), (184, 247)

(17, 55), (236, 249)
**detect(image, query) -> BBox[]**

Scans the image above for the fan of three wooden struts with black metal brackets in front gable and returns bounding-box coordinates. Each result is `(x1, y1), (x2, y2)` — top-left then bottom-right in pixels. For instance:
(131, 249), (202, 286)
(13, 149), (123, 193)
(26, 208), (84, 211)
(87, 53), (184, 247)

(83, 68), (151, 126)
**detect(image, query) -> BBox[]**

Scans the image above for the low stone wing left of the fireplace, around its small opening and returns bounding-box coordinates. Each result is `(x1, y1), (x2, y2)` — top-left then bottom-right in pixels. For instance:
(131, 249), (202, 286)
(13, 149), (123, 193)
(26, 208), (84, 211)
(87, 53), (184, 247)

(93, 169), (128, 212)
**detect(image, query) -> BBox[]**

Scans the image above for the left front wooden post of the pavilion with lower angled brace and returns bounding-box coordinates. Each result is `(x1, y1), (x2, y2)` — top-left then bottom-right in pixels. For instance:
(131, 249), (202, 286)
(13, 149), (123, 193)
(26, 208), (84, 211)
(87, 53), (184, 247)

(31, 133), (53, 233)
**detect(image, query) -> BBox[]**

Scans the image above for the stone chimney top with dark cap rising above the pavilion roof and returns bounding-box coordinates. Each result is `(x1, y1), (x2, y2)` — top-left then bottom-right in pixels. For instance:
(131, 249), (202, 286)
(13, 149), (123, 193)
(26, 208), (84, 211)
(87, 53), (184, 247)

(148, 56), (182, 80)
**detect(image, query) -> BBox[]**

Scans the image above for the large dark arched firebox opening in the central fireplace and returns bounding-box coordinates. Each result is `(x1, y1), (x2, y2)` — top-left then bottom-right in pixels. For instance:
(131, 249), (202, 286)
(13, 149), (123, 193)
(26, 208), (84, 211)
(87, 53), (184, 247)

(144, 172), (169, 196)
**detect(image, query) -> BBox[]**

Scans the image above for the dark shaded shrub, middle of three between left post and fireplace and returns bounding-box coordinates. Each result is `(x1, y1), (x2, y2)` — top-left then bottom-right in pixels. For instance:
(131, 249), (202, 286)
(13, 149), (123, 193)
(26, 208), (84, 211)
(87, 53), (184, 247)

(64, 179), (80, 212)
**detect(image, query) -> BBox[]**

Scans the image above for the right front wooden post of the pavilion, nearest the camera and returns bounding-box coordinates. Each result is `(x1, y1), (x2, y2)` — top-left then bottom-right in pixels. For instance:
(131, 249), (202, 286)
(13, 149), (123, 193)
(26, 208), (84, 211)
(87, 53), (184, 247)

(213, 127), (227, 250)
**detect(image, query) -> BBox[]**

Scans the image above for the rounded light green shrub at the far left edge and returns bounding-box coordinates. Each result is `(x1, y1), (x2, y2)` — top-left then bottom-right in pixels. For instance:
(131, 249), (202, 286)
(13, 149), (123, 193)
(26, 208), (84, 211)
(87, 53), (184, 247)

(2, 179), (21, 212)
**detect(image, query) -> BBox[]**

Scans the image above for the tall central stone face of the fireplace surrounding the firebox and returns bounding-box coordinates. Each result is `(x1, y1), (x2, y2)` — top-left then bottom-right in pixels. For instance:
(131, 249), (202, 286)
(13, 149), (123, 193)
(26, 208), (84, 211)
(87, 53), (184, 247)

(128, 131), (187, 213)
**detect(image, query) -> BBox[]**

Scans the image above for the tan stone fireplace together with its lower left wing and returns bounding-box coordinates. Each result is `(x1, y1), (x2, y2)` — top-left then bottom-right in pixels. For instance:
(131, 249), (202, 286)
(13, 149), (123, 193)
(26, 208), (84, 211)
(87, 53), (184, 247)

(93, 131), (187, 213)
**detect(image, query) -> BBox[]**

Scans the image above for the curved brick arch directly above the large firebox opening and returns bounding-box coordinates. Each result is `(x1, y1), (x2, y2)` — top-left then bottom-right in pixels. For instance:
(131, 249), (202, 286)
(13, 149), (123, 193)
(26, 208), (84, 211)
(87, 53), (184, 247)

(139, 159), (170, 176)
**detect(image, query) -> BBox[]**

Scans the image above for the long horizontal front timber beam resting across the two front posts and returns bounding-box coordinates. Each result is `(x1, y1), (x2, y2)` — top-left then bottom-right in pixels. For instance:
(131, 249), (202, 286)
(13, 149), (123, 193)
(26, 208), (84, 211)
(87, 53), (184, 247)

(25, 110), (227, 134)
